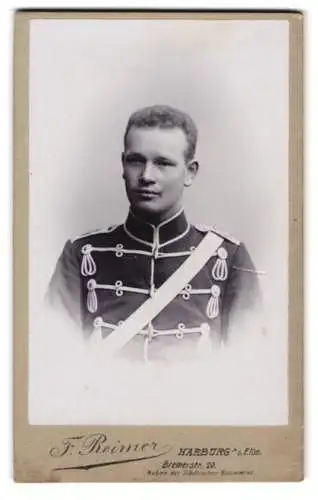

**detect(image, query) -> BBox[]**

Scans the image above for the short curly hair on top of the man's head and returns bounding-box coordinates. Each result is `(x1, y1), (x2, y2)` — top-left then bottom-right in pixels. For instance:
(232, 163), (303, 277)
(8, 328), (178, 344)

(124, 104), (198, 161)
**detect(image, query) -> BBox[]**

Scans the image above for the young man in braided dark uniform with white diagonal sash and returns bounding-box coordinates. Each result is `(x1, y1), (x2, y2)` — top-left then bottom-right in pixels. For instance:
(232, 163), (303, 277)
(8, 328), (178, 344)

(49, 106), (260, 360)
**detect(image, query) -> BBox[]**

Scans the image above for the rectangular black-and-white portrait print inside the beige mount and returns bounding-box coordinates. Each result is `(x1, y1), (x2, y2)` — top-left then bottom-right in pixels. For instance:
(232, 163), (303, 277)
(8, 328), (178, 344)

(29, 20), (288, 425)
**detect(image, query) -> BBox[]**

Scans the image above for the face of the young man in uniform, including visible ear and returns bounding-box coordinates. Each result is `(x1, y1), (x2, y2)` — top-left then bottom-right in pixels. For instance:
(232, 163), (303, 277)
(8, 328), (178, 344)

(122, 127), (198, 220)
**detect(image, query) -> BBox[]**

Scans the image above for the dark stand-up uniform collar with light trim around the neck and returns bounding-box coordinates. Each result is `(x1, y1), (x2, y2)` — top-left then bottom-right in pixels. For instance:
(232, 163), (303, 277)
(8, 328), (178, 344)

(124, 208), (190, 247)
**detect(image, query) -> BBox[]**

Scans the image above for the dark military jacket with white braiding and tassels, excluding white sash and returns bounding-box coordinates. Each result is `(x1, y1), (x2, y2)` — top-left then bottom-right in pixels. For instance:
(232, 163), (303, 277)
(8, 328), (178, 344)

(49, 211), (260, 359)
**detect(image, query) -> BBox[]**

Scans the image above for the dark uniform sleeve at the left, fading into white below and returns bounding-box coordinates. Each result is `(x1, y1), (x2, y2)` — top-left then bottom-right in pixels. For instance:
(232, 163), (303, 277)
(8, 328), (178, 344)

(46, 240), (81, 326)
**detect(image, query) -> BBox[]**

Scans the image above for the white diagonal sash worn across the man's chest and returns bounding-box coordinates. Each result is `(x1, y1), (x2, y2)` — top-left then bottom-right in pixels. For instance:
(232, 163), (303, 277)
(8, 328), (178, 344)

(95, 232), (223, 355)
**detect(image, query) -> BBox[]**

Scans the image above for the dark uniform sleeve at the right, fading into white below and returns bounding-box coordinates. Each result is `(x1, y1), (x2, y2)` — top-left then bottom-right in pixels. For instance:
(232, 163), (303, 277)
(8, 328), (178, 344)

(222, 243), (265, 337)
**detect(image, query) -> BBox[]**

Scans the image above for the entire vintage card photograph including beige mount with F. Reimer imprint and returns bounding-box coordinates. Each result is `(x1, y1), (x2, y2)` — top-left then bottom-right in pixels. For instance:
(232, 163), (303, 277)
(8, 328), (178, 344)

(14, 11), (303, 482)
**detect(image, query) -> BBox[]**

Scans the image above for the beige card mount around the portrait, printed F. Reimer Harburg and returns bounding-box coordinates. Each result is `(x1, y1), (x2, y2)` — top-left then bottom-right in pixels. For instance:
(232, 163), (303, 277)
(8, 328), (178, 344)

(13, 11), (303, 482)
